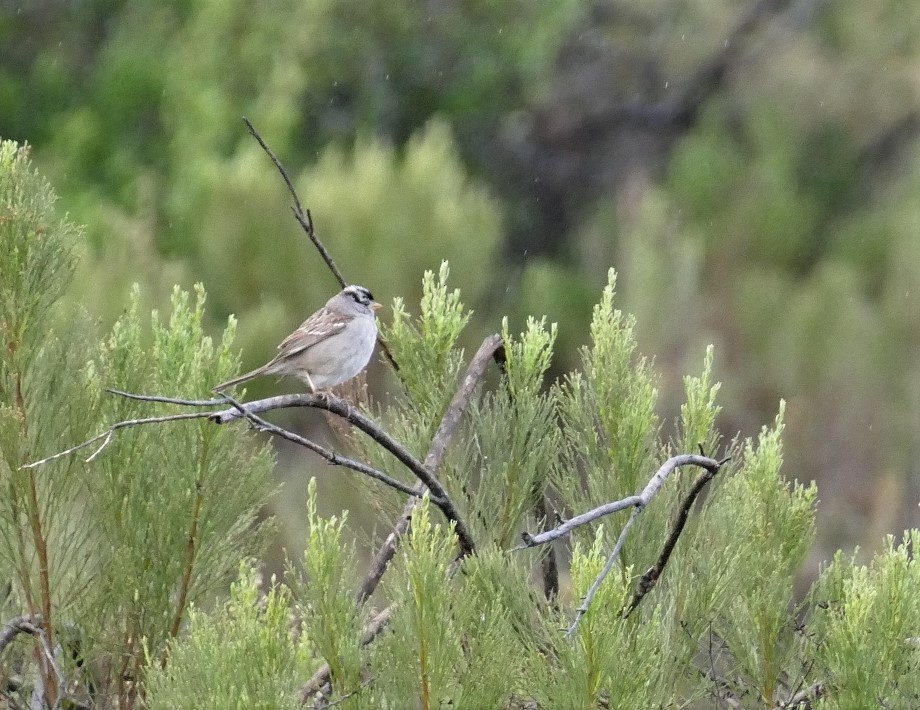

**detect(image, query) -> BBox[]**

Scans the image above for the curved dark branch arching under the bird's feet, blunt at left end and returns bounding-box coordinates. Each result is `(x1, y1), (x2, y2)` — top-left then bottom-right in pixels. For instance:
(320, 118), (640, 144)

(211, 392), (476, 555)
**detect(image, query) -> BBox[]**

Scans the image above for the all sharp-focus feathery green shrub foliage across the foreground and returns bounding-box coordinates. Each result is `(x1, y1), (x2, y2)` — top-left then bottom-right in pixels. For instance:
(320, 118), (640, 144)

(0, 139), (920, 708)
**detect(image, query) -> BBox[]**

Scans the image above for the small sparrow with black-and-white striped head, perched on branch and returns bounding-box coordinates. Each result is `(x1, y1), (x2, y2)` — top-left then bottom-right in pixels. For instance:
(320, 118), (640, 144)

(214, 286), (380, 392)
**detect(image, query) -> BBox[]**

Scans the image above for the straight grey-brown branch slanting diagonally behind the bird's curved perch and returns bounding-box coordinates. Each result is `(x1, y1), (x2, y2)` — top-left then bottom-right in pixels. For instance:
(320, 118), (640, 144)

(300, 334), (502, 702)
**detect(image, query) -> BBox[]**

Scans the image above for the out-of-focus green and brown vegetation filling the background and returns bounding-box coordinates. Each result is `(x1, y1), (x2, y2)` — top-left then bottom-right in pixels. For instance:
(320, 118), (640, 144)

(0, 0), (920, 576)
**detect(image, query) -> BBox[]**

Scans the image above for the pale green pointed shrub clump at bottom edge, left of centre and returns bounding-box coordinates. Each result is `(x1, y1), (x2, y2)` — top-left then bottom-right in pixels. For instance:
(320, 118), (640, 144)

(145, 563), (306, 710)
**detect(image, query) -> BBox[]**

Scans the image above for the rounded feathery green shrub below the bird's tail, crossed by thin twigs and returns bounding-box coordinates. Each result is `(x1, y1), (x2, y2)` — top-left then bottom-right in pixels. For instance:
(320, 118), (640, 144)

(86, 286), (272, 684)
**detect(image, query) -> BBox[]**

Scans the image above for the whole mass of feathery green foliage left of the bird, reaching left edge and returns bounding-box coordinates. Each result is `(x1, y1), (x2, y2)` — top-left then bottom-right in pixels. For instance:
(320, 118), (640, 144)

(0, 147), (272, 705)
